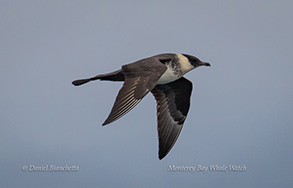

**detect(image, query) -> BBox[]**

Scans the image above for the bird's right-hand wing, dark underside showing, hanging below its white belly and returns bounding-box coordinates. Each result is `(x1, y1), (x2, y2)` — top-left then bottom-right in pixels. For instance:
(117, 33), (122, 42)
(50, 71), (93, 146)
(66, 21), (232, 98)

(152, 77), (192, 159)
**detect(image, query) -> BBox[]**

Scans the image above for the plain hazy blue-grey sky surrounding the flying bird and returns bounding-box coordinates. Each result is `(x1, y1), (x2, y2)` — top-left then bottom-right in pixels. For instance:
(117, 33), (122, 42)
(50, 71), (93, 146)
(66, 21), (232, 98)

(0, 0), (293, 188)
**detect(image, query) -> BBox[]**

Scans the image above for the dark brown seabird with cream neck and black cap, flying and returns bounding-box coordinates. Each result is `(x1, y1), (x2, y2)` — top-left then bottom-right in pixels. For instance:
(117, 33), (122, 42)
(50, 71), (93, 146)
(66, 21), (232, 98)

(72, 53), (211, 160)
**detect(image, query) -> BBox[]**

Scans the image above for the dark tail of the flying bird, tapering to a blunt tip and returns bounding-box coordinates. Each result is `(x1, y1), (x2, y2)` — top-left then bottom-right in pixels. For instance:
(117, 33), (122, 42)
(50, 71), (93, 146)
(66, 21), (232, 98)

(72, 69), (125, 86)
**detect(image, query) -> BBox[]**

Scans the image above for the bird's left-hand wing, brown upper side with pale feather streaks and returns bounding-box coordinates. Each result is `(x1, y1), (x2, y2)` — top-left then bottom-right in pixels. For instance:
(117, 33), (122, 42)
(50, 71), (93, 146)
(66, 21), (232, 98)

(103, 57), (167, 125)
